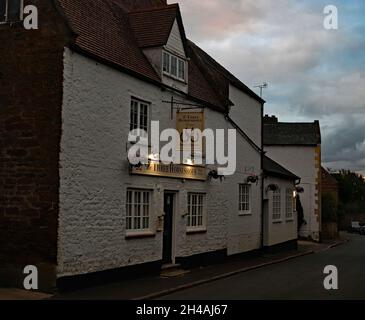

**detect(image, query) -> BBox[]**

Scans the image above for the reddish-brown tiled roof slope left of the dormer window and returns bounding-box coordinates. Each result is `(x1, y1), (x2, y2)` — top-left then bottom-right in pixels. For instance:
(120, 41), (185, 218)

(58, 0), (160, 81)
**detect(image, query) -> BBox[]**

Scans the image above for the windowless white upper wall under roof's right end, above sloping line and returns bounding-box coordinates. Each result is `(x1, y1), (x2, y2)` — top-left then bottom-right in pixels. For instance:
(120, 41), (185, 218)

(229, 85), (262, 147)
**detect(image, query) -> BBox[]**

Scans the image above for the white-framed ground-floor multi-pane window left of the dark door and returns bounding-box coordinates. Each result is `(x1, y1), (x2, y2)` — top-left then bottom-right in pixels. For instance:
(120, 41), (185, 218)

(125, 188), (153, 236)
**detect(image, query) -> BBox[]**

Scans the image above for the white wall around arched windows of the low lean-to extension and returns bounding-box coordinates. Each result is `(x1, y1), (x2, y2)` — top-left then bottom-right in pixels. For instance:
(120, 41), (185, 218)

(264, 176), (298, 247)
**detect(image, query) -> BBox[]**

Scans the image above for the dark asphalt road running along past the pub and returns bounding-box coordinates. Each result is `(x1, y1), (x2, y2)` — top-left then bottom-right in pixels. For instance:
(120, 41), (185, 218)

(161, 235), (365, 300)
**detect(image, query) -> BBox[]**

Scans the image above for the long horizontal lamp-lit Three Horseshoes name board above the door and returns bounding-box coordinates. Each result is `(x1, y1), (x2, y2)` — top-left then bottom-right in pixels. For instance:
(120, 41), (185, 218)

(131, 162), (207, 181)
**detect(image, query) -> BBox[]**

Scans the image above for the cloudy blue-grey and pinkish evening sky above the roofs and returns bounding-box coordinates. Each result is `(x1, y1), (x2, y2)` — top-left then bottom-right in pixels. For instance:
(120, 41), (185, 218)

(176, 0), (365, 174)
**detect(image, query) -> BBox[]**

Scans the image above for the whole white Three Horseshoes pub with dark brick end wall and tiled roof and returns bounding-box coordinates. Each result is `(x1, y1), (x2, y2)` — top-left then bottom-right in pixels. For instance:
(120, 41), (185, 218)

(0, 0), (296, 289)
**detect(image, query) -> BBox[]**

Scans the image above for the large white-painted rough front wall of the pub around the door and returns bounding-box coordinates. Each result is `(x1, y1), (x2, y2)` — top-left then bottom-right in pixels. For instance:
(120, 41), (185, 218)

(58, 49), (261, 277)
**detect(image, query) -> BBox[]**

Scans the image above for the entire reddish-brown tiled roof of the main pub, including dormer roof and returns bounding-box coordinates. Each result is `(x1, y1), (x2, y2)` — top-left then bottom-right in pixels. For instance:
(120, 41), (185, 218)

(55, 0), (263, 112)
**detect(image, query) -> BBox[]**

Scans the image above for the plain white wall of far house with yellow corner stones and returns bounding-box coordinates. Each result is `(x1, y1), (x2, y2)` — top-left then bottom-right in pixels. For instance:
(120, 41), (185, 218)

(265, 146), (320, 240)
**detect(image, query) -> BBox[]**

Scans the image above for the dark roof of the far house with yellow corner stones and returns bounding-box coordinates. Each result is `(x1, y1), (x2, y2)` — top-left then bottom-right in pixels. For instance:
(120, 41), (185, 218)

(264, 121), (321, 146)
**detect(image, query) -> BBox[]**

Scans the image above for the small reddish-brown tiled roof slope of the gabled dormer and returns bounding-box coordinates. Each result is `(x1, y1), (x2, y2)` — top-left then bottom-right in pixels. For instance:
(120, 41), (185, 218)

(129, 5), (178, 48)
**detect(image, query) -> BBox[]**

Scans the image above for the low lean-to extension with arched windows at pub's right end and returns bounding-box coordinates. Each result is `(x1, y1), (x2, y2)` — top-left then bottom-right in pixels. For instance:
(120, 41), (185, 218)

(263, 156), (300, 250)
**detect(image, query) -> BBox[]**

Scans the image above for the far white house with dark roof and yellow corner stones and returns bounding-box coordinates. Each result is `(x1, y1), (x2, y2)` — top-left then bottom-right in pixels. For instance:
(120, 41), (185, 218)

(263, 116), (321, 241)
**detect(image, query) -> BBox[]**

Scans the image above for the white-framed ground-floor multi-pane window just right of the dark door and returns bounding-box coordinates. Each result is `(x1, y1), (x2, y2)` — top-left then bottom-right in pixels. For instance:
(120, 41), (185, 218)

(186, 192), (207, 232)
